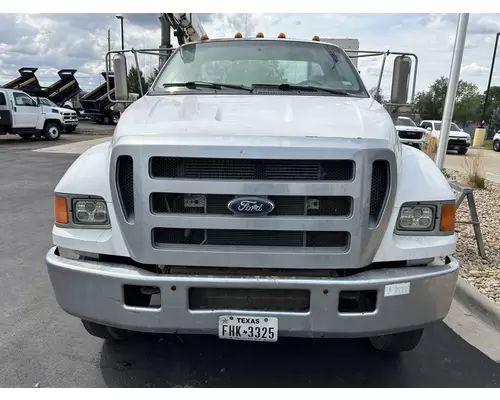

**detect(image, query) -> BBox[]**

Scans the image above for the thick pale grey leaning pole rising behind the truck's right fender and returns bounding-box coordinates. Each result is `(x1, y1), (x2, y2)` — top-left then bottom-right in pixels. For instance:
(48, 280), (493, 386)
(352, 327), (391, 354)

(436, 14), (469, 170)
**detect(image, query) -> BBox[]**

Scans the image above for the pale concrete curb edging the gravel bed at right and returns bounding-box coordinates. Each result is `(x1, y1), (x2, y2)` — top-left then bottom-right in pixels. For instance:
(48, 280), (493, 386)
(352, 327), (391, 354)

(455, 277), (500, 331)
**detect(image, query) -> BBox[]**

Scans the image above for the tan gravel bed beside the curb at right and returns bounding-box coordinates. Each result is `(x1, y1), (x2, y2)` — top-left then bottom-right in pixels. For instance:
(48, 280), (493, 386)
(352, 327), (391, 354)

(446, 170), (500, 305)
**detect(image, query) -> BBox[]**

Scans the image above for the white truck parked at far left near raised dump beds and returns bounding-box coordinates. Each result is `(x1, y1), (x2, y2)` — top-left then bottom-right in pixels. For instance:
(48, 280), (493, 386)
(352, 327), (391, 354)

(0, 88), (65, 140)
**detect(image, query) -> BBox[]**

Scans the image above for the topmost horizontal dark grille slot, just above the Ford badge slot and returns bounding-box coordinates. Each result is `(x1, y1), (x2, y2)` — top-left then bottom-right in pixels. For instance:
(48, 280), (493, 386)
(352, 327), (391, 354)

(150, 157), (354, 181)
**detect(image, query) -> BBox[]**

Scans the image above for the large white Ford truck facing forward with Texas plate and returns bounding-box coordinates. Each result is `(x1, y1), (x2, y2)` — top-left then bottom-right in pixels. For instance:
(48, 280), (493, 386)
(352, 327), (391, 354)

(45, 21), (459, 352)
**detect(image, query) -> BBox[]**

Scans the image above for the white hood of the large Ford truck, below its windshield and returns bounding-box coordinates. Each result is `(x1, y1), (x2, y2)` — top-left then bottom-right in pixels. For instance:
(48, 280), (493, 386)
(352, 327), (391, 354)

(114, 93), (397, 143)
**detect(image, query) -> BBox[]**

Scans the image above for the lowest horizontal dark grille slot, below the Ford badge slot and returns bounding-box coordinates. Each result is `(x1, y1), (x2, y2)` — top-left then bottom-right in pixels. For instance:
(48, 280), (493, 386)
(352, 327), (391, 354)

(153, 228), (349, 249)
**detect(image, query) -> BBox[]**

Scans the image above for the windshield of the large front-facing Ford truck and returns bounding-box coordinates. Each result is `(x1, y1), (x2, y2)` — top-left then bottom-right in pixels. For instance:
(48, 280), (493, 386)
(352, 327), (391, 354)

(152, 40), (368, 97)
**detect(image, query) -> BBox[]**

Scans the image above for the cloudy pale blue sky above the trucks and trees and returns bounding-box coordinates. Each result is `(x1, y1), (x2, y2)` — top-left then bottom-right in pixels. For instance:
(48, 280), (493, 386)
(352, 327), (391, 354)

(0, 13), (500, 94)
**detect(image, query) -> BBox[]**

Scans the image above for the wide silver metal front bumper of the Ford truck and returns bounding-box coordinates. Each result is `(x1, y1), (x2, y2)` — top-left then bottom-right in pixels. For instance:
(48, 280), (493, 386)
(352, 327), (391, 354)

(46, 247), (459, 337)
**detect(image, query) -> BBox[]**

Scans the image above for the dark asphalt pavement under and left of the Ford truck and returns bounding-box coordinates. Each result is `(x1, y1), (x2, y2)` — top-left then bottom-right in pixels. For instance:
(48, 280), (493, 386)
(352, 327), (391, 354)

(0, 135), (500, 388)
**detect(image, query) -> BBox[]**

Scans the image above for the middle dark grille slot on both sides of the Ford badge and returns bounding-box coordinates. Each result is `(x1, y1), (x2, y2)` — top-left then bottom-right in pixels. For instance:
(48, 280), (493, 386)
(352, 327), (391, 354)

(151, 193), (352, 217)
